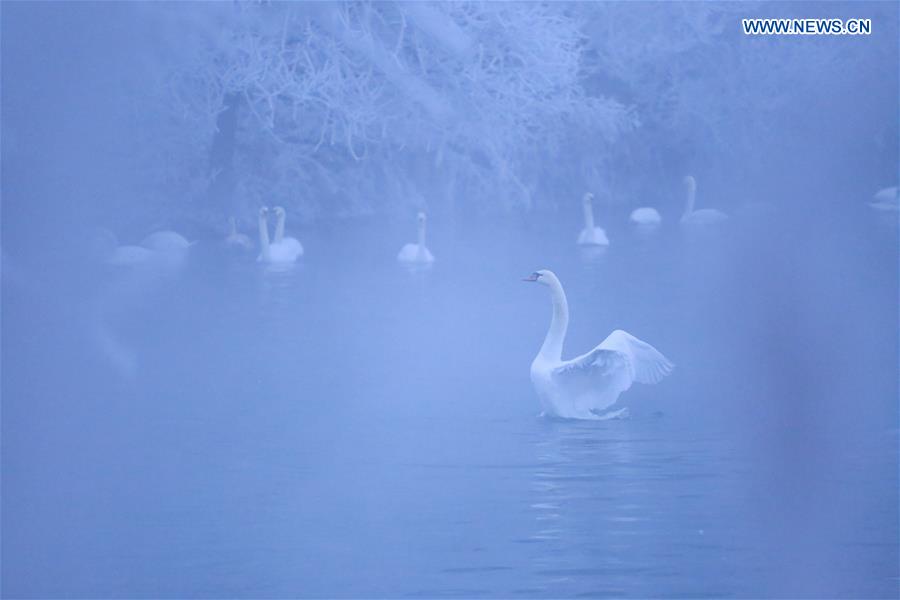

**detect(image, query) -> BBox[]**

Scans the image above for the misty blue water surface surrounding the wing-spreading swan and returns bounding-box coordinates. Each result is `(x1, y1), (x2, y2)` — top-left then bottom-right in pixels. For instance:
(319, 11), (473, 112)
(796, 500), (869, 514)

(2, 207), (898, 597)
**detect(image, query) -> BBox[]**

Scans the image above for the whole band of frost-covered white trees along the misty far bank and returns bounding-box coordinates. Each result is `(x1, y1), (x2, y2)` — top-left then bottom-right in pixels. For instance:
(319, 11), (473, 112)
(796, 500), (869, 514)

(128, 2), (896, 222)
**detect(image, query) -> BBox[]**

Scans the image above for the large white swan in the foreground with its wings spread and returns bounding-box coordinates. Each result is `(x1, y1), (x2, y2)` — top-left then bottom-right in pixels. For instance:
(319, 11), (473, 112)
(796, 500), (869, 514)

(523, 270), (674, 420)
